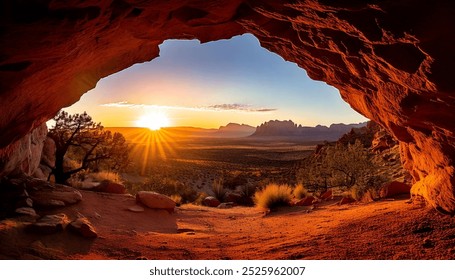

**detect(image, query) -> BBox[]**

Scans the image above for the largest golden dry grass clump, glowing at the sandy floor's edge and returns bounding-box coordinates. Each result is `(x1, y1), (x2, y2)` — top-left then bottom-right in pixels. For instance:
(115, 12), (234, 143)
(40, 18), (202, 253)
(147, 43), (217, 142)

(254, 184), (292, 209)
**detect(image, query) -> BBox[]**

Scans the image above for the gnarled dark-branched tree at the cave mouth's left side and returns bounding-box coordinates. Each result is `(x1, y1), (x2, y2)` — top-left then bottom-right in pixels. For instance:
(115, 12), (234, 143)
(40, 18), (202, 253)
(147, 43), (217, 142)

(48, 111), (129, 184)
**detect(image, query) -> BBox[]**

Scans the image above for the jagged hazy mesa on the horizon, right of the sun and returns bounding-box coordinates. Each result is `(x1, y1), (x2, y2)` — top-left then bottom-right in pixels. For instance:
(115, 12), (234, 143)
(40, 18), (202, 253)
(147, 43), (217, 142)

(251, 120), (367, 141)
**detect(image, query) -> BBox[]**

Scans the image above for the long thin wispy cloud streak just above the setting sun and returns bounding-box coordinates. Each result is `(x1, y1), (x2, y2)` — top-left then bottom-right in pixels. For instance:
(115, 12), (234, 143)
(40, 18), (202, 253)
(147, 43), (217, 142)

(100, 101), (277, 113)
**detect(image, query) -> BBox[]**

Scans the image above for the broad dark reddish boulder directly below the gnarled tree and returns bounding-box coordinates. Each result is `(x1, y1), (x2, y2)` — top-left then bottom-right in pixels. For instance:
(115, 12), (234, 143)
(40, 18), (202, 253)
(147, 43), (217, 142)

(27, 179), (82, 207)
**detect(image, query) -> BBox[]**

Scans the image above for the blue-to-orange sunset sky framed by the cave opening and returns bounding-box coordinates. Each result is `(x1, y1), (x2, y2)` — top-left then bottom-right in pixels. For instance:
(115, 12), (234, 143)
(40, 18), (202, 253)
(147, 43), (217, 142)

(66, 34), (366, 128)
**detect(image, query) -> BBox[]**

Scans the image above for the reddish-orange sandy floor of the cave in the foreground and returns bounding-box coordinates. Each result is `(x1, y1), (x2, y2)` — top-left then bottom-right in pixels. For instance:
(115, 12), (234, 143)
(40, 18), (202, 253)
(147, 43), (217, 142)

(0, 191), (455, 260)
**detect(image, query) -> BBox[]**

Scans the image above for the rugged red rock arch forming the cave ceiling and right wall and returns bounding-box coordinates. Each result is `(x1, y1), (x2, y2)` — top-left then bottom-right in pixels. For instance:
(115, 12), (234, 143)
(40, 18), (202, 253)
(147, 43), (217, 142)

(0, 0), (455, 214)
